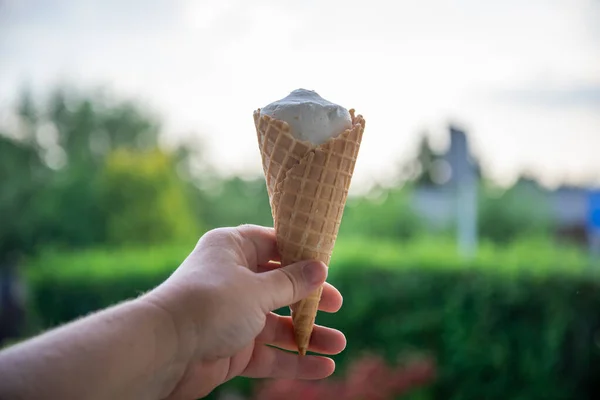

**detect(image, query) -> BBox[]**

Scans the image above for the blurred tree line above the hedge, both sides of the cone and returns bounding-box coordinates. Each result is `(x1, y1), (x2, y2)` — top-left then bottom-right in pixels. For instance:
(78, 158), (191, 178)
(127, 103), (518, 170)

(0, 83), (564, 264)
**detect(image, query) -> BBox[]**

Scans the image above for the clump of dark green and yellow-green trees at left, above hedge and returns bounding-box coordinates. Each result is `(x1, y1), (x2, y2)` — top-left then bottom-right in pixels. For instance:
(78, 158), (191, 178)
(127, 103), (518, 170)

(0, 88), (198, 266)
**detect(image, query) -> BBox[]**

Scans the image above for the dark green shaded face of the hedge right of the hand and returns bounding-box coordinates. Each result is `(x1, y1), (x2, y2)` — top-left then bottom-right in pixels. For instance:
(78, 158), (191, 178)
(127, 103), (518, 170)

(318, 268), (600, 399)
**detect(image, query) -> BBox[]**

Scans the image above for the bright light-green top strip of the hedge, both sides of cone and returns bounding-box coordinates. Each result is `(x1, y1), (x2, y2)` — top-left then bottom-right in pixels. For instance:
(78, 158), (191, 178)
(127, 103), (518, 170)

(26, 237), (600, 286)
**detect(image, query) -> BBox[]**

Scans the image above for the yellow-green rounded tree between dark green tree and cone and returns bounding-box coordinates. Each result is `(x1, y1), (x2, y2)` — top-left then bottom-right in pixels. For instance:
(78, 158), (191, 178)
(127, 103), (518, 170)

(99, 149), (199, 245)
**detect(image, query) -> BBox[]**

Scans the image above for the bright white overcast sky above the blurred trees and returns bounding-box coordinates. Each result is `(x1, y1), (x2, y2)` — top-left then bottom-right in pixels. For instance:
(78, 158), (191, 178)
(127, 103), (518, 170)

(0, 0), (600, 194)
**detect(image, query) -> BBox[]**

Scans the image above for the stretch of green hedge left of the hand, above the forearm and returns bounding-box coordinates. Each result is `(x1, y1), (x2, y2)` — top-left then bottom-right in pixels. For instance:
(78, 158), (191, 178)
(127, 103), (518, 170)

(26, 243), (193, 328)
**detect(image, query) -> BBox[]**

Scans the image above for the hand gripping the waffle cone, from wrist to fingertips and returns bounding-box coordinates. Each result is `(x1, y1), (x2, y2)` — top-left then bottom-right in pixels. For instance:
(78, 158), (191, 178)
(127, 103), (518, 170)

(145, 225), (346, 399)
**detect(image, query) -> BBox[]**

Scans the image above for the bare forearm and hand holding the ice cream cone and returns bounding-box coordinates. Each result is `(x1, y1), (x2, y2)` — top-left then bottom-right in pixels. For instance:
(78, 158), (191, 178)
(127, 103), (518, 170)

(0, 225), (346, 399)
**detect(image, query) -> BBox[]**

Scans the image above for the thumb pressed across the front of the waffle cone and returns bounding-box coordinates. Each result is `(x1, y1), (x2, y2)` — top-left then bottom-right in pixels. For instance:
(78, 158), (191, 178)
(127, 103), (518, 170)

(259, 261), (327, 311)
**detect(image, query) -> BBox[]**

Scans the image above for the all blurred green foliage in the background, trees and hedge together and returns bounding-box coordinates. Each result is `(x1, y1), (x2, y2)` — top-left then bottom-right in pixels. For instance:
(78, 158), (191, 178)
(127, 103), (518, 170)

(0, 83), (600, 399)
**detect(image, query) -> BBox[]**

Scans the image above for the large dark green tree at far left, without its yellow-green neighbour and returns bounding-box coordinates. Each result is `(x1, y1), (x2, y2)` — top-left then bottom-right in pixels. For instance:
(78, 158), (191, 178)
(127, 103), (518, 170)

(0, 87), (204, 260)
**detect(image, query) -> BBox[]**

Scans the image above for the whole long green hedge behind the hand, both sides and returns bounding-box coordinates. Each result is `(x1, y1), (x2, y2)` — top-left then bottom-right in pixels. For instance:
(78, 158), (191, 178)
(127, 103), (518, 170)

(22, 241), (600, 400)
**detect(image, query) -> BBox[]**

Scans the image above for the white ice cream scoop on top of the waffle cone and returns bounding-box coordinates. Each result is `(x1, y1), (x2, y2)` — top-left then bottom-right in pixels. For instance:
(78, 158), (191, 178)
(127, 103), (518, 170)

(260, 89), (352, 146)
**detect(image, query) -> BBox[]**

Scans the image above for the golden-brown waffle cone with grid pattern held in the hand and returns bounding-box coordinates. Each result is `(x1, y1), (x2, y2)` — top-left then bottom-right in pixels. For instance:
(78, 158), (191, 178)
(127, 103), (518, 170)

(254, 110), (365, 355)
